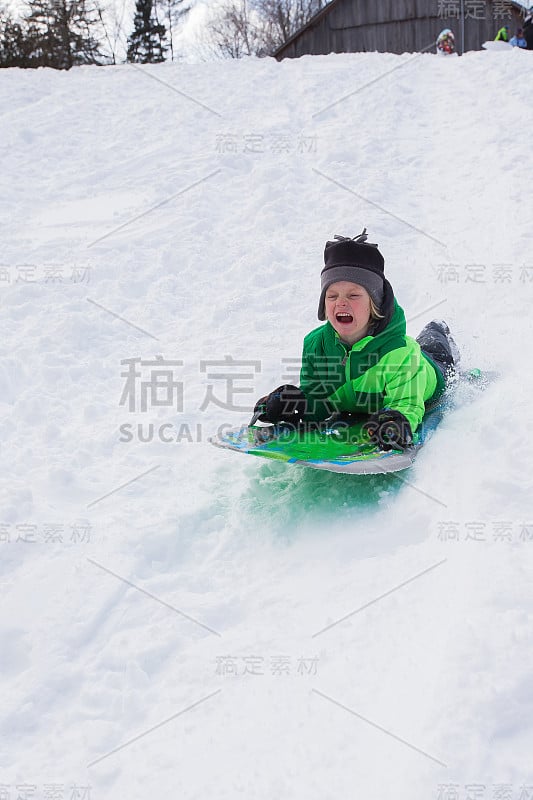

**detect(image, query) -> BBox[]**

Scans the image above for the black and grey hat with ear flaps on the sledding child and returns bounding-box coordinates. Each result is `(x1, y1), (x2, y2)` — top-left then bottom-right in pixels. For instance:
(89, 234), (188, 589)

(318, 228), (385, 320)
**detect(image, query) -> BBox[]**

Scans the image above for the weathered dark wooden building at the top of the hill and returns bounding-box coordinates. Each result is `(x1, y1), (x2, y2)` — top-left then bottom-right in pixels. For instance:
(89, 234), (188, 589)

(274, 0), (533, 60)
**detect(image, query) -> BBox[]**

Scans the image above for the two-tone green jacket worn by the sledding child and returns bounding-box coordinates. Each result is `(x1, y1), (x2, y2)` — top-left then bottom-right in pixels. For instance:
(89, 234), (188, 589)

(300, 291), (445, 432)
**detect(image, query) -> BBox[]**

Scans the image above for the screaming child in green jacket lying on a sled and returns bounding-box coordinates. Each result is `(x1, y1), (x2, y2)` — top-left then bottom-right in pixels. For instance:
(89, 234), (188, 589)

(251, 228), (458, 449)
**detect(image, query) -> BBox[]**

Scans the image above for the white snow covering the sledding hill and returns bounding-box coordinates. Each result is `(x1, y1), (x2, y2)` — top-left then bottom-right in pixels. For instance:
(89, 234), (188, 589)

(0, 49), (533, 800)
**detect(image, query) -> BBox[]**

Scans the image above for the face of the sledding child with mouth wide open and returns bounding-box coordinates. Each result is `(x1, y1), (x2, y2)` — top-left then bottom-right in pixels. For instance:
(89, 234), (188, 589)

(325, 281), (371, 345)
